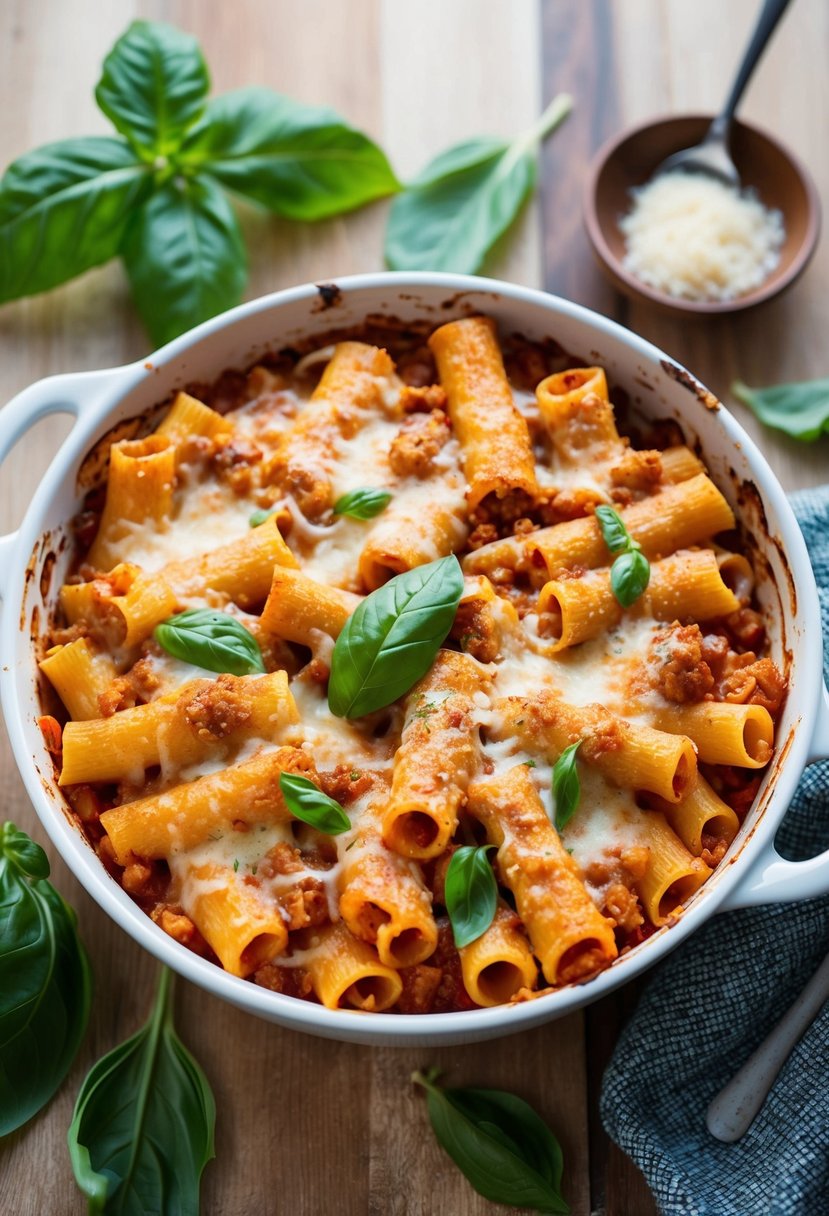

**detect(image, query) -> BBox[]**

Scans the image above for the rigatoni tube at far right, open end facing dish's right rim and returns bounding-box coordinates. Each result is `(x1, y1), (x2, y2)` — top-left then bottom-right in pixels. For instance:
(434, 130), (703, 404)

(649, 700), (774, 769)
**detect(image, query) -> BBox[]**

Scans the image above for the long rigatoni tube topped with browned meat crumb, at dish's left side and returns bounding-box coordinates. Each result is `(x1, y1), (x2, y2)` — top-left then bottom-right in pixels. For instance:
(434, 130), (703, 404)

(60, 671), (298, 786)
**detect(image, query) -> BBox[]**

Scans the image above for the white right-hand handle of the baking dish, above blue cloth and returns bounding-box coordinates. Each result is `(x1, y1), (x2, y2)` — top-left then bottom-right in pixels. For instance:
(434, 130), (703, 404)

(720, 685), (829, 912)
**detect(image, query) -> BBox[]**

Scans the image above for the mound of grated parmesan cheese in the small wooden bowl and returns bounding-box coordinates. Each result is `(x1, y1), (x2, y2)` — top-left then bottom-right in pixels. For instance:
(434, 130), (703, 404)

(619, 173), (785, 300)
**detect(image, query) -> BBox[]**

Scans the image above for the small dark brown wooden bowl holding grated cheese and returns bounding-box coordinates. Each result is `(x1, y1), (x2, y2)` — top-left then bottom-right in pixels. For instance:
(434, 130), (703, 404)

(583, 114), (820, 315)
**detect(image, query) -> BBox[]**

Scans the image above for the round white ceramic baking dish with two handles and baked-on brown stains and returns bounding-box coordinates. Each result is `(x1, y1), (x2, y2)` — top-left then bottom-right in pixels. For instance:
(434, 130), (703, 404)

(0, 274), (829, 1045)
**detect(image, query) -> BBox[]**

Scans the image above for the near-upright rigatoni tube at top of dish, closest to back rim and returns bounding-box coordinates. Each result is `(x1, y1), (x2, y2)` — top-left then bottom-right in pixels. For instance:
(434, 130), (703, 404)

(429, 316), (538, 511)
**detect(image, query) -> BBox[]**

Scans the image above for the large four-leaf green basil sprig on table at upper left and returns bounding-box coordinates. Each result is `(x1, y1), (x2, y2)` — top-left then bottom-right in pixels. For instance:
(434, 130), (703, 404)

(0, 21), (399, 344)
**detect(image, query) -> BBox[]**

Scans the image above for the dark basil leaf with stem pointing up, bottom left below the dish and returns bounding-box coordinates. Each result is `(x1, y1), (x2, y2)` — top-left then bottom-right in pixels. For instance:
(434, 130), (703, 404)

(68, 968), (215, 1216)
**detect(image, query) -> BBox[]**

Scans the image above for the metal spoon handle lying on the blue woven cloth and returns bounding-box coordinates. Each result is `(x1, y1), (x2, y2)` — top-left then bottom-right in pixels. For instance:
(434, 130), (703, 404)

(705, 955), (829, 1144)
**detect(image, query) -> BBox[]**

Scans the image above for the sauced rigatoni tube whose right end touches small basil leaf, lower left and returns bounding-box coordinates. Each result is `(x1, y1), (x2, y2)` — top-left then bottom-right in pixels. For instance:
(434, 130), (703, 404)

(101, 748), (314, 866)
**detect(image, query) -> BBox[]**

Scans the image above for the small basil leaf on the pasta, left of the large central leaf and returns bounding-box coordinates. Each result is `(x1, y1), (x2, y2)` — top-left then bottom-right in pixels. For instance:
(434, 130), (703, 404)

(153, 608), (265, 676)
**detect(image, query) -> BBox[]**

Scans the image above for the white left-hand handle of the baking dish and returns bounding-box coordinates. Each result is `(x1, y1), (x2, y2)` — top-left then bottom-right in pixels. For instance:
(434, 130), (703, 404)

(0, 367), (129, 599)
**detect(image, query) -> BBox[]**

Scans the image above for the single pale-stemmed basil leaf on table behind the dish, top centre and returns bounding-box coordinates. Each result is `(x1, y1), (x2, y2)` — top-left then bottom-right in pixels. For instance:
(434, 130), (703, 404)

(385, 95), (571, 274)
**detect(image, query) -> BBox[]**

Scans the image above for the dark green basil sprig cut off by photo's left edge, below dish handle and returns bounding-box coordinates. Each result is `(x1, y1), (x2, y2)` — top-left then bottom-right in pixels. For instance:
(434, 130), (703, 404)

(0, 823), (92, 1136)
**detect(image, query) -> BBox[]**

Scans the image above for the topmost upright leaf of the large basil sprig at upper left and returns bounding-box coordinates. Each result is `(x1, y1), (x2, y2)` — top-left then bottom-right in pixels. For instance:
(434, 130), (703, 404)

(95, 21), (210, 161)
